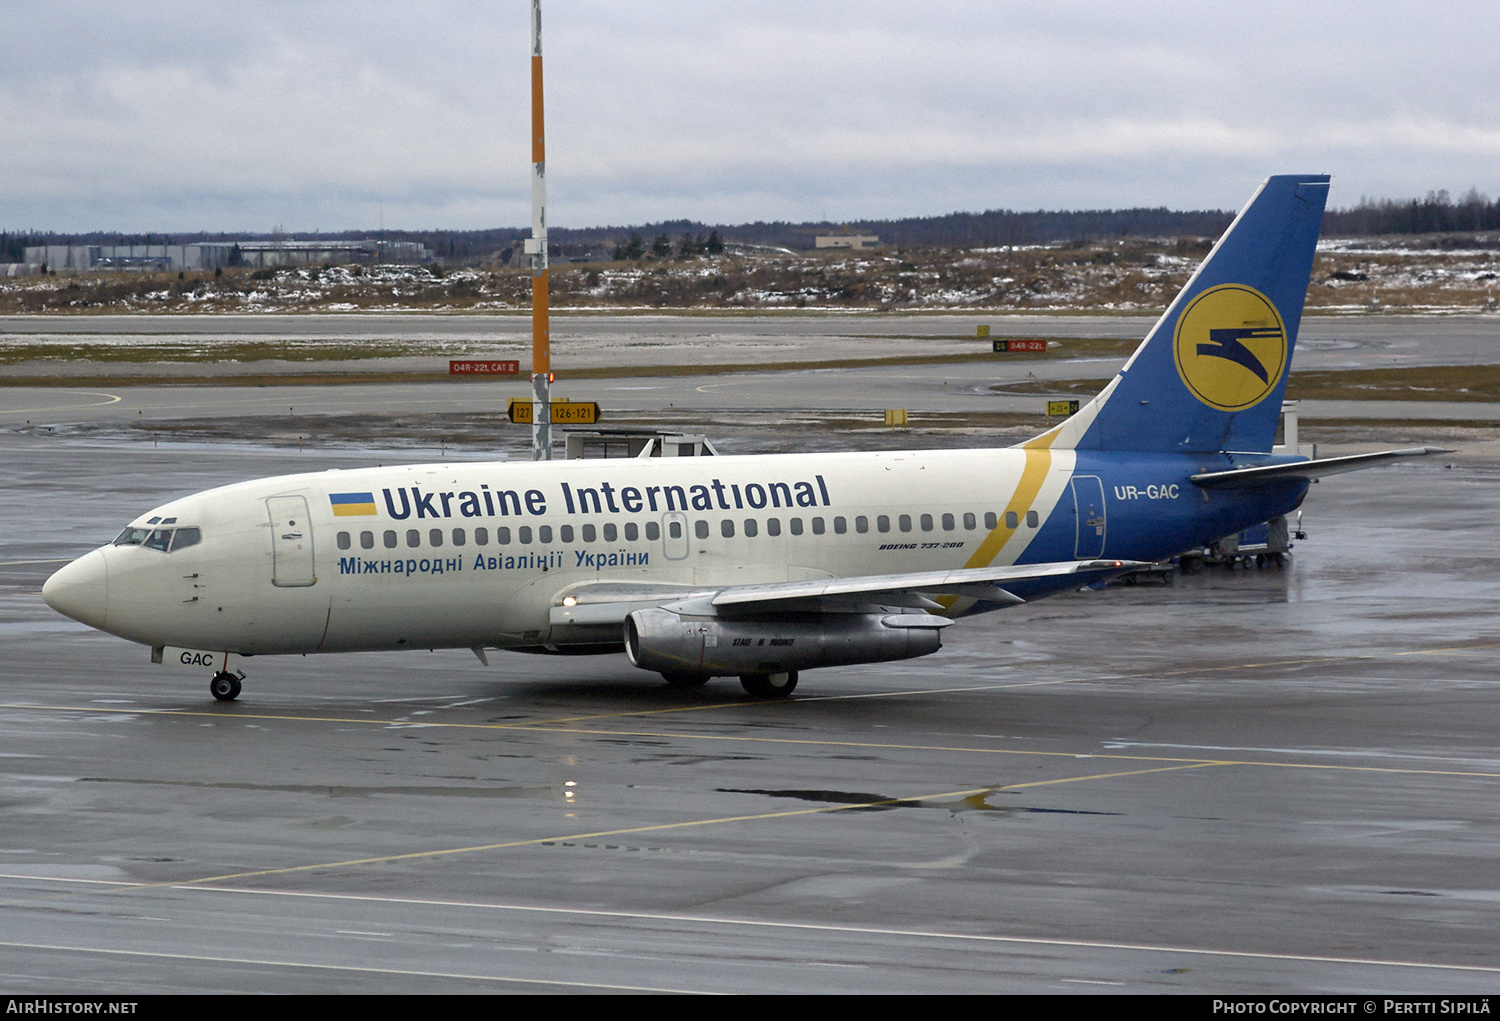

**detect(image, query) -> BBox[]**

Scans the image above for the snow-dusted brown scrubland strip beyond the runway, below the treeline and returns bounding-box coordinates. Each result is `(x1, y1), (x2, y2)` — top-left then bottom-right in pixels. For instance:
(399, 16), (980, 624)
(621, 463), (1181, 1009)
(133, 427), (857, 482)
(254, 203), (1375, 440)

(0, 238), (1500, 315)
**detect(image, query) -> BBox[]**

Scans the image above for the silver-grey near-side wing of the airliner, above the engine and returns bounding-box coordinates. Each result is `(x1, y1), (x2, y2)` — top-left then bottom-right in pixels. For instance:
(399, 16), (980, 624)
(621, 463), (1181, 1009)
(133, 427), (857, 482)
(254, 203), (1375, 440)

(551, 561), (1151, 625)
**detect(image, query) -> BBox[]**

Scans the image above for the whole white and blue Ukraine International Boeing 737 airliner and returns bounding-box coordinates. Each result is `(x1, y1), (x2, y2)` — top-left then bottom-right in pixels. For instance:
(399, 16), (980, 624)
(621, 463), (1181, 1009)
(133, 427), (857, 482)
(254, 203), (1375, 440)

(42, 175), (1445, 700)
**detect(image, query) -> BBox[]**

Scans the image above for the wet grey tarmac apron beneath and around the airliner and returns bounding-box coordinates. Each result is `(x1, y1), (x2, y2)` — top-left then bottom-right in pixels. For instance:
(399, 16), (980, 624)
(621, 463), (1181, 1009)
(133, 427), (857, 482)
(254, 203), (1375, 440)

(0, 416), (1500, 994)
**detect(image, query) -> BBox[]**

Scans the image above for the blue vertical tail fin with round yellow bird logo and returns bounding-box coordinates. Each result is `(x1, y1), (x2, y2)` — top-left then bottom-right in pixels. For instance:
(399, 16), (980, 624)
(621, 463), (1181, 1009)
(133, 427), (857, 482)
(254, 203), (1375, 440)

(1050, 174), (1328, 453)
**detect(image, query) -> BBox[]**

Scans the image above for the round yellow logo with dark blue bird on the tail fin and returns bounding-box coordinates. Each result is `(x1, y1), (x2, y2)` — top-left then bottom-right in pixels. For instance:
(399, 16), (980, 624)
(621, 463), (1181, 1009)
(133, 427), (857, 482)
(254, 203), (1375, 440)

(1173, 283), (1287, 411)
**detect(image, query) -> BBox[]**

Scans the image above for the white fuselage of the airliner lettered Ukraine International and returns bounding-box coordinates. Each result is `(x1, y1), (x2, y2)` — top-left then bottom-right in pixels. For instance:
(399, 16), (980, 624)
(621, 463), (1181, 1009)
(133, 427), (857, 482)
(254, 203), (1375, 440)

(58, 448), (1098, 654)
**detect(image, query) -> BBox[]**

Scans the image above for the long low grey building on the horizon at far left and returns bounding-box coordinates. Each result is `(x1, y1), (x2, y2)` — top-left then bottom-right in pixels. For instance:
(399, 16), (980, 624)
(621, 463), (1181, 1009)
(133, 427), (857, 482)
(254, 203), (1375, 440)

(26, 240), (434, 271)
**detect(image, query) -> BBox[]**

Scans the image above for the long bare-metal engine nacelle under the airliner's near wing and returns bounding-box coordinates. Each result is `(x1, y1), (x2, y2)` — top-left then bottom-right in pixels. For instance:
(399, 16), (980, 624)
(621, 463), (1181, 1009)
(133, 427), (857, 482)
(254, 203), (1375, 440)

(626, 609), (953, 676)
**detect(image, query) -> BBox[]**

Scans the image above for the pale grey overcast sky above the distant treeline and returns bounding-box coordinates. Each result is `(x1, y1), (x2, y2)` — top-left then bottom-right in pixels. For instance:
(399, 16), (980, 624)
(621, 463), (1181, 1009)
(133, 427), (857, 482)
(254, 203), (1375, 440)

(0, 0), (1500, 231)
